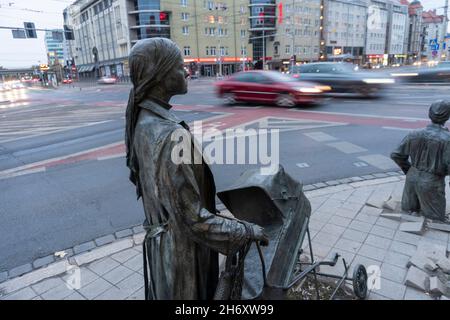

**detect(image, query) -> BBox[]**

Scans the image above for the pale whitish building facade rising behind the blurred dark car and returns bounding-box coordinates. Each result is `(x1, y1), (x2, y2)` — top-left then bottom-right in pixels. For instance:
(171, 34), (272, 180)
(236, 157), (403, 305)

(325, 0), (368, 63)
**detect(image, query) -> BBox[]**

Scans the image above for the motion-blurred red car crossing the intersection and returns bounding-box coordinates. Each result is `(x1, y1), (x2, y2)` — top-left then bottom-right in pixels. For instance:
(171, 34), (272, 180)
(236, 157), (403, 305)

(215, 71), (329, 107)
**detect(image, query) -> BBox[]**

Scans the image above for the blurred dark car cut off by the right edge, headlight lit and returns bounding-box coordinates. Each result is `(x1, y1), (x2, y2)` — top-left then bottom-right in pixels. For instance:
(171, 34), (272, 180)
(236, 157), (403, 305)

(391, 61), (450, 83)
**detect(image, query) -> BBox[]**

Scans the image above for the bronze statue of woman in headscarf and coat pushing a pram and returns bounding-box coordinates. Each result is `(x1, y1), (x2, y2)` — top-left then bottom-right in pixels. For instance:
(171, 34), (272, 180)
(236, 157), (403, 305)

(125, 38), (267, 299)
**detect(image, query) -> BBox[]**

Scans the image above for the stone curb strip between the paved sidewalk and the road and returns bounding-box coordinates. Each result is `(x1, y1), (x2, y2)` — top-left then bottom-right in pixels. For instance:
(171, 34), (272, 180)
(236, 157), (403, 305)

(0, 171), (404, 290)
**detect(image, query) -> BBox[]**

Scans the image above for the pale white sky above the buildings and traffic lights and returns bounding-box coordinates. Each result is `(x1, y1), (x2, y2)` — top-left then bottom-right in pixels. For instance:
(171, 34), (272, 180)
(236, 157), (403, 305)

(0, 0), (444, 68)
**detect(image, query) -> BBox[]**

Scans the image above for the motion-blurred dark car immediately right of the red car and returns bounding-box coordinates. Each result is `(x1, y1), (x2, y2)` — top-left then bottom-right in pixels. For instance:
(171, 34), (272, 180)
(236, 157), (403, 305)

(289, 62), (395, 97)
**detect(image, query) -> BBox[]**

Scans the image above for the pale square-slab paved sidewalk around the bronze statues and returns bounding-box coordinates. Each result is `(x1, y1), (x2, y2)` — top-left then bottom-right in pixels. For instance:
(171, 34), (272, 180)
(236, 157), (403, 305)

(0, 176), (450, 300)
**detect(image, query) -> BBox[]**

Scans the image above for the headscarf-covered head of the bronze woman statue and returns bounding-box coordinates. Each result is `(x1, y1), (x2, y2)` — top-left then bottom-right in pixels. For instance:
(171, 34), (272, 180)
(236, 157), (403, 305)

(129, 38), (187, 101)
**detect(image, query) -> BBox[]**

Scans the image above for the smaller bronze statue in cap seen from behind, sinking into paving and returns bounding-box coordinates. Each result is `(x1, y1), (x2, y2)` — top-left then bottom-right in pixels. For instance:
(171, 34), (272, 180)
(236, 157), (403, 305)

(391, 100), (450, 221)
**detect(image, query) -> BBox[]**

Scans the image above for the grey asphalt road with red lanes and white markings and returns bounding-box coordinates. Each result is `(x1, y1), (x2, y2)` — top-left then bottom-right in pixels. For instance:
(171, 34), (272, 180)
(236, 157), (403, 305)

(0, 80), (450, 271)
